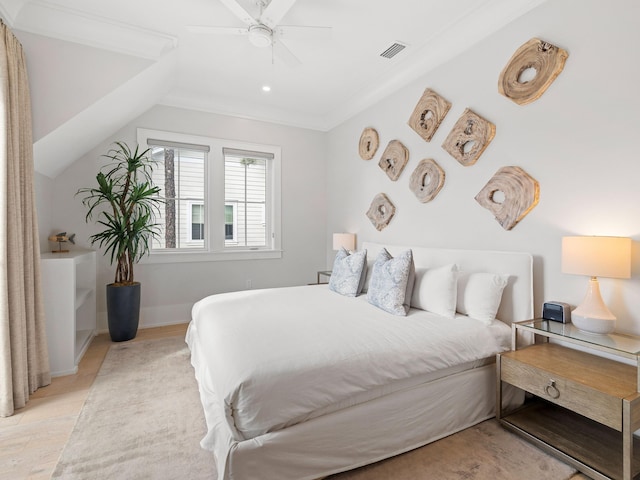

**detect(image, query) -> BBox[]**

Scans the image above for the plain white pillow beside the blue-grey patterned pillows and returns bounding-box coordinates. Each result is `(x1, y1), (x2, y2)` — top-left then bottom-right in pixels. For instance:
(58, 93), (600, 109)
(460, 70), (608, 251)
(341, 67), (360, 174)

(411, 263), (458, 318)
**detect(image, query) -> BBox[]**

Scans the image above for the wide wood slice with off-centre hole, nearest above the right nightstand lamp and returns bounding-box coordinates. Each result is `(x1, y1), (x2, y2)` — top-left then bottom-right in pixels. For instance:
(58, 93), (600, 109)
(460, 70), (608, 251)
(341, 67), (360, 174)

(475, 167), (540, 230)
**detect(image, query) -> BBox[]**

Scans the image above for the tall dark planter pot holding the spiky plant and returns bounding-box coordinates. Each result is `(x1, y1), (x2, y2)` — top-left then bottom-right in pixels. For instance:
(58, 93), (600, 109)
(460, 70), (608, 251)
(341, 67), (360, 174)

(107, 282), (140, 342)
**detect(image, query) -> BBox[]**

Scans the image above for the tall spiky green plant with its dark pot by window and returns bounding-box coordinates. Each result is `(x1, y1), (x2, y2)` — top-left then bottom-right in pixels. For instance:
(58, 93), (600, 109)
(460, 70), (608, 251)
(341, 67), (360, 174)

(76, 142), (162, 342)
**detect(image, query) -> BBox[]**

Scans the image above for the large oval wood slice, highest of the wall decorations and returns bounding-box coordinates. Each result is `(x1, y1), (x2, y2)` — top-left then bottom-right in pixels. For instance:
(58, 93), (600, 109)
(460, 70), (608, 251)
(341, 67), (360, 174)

(498, 38), (569, 105)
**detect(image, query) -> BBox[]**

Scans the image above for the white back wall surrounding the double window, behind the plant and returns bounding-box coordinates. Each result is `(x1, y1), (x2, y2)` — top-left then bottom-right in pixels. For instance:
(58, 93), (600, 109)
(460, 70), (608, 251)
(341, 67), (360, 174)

(52, 106), (326, 330)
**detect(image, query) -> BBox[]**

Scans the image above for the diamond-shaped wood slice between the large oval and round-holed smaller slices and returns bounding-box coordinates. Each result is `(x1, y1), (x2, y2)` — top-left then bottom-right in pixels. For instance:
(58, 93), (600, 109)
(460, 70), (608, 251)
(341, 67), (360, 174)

(442, 108), (496, 167)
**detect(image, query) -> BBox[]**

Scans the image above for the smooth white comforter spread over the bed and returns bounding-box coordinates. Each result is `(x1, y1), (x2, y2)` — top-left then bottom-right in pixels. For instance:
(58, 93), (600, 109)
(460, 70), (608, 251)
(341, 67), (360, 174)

(187, 286), (510, 441)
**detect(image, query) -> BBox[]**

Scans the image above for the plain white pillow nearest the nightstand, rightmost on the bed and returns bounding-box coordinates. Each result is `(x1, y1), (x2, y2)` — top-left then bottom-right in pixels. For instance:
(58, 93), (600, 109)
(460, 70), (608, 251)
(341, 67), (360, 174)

(456, 273), (509, 323)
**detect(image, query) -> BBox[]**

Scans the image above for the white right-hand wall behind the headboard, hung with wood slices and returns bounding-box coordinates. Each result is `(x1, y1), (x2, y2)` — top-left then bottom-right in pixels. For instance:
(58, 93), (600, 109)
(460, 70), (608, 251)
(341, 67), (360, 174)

(326, 0), (640, 333)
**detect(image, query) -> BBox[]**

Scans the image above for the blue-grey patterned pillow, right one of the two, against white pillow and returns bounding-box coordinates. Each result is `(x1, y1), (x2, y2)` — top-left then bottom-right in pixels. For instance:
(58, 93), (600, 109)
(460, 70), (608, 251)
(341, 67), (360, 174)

(367, 248), (415, 315)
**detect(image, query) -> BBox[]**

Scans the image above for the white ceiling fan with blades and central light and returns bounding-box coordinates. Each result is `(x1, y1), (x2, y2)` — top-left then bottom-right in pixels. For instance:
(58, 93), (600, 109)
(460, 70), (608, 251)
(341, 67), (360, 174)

(187, 0), (331, 67)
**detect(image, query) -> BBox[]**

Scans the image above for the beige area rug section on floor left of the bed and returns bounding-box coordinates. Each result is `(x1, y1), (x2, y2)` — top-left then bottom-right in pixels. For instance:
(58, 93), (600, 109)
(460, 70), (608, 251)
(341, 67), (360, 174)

(52, 337), (215, 480)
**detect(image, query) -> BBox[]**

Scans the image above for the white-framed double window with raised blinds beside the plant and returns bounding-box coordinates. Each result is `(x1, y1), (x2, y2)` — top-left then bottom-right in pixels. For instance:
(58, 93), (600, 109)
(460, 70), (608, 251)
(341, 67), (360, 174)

(138, 129), (281, 263)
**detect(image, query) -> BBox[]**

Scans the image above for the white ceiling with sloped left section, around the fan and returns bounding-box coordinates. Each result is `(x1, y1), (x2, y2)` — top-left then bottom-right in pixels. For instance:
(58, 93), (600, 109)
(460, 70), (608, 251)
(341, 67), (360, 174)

(0, 0), (546, 178)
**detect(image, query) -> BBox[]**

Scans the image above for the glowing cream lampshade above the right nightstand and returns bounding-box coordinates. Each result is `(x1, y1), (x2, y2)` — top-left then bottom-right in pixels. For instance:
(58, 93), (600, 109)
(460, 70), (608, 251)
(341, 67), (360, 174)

(562, 237), (631, 278)
